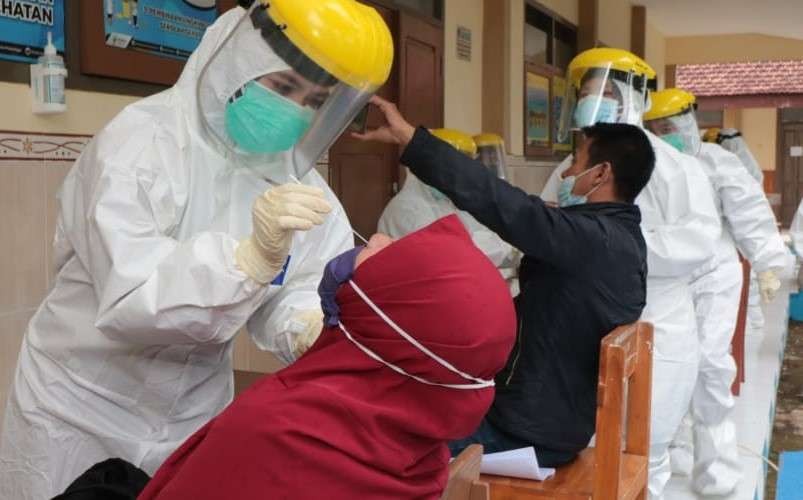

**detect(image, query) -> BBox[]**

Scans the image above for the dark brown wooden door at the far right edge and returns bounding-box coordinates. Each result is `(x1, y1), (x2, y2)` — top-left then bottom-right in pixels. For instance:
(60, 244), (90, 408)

(775, 123), (803, 227)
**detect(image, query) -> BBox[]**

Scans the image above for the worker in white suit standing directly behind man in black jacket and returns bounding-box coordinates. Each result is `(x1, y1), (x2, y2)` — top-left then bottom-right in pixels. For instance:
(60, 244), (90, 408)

(541, 48), (721, 499)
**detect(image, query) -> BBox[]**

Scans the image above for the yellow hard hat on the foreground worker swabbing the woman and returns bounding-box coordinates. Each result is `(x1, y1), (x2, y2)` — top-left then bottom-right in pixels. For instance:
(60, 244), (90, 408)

(261, 0), (393, 89)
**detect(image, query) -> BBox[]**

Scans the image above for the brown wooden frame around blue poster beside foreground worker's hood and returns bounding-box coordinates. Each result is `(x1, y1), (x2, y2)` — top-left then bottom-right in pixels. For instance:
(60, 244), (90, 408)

(76, 0), (237, 85)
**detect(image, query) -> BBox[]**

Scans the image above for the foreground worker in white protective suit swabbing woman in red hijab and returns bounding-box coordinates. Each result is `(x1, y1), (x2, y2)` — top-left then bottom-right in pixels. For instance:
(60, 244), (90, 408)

(0, 0), (392, 500)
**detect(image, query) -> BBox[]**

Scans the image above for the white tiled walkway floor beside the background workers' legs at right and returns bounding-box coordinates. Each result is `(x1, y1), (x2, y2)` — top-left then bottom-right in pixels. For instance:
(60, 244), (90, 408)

(666, 285), (789, 500)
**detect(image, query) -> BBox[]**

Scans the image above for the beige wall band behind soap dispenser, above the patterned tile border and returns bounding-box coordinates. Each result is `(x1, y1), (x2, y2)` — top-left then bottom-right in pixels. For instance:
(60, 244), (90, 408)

(0, 82), (141, 135)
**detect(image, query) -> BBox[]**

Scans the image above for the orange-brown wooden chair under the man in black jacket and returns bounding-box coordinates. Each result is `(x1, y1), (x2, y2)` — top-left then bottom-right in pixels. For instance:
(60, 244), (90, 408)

(482, 323), (653, 500)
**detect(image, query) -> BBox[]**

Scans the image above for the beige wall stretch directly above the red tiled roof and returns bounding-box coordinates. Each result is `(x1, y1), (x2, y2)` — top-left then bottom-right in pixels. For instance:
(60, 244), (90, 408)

(666, 34), (803, 64)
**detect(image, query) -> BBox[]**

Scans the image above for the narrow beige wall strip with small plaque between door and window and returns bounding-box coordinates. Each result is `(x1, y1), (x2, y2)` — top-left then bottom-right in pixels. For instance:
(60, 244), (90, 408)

(443, 0), (483, 134)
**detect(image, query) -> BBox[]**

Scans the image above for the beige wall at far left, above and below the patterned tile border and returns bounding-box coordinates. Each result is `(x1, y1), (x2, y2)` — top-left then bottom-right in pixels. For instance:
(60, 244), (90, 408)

(0, 82), (139, 415)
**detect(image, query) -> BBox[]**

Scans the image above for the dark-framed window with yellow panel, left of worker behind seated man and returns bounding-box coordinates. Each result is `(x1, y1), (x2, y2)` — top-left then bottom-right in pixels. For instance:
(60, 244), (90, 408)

(524, 2), (577, 159)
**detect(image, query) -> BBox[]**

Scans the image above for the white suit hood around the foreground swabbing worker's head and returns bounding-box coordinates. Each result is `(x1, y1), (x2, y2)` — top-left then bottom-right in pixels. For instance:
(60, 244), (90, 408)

(174, 7), (290, 165)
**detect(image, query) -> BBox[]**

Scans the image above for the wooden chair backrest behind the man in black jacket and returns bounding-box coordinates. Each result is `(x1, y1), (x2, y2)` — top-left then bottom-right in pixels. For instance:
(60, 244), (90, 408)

(594, 322), (653, 500)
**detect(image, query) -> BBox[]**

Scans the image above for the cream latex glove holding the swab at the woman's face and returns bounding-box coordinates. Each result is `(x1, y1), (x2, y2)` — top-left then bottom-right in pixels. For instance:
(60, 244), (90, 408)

(235, 184), (332, 285)
